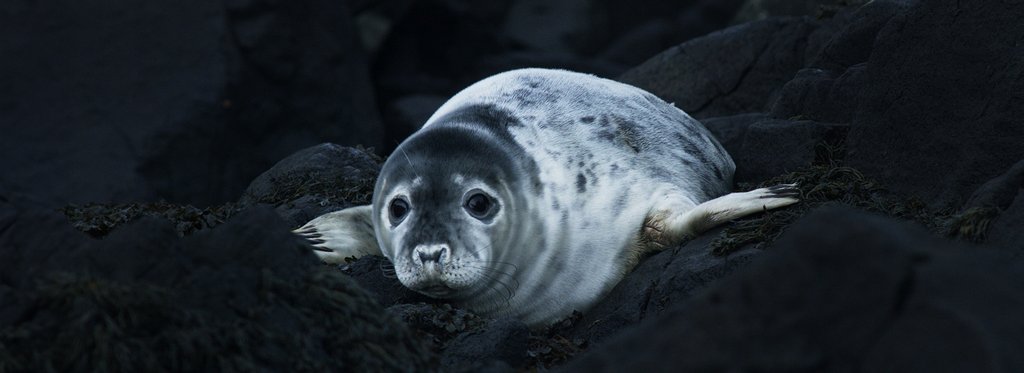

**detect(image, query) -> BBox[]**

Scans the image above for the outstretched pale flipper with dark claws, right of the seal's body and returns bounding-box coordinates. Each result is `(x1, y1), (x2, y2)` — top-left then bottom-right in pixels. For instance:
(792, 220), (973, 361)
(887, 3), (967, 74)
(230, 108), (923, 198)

(643, 183), (800, 248)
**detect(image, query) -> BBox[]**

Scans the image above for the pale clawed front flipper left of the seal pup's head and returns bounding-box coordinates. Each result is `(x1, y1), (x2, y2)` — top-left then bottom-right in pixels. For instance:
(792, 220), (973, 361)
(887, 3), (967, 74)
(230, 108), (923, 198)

(292, 205), (381, 263)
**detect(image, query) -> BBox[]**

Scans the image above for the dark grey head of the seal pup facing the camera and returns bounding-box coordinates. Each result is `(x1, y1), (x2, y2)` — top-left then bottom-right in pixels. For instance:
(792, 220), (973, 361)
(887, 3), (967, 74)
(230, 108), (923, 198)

(373, 108), (536, 300)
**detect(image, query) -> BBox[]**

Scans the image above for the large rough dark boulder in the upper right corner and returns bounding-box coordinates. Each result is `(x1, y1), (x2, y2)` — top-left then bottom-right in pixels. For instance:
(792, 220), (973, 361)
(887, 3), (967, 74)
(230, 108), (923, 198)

(847, 0), (1024, 208)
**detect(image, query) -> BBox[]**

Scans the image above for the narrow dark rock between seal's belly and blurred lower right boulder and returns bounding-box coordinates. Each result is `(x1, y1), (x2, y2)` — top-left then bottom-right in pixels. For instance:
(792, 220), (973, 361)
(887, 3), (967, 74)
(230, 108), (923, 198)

(568, 230), (760, 343)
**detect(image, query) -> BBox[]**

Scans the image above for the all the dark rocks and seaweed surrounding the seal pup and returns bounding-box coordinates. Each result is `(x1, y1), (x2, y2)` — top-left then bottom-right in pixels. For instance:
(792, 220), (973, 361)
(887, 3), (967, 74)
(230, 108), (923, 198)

(0, 0), (1024, 372)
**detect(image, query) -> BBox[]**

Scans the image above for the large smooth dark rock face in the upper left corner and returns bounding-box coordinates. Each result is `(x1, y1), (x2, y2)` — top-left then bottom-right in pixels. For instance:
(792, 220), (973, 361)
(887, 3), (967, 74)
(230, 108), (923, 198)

(0, 1), (228, 207)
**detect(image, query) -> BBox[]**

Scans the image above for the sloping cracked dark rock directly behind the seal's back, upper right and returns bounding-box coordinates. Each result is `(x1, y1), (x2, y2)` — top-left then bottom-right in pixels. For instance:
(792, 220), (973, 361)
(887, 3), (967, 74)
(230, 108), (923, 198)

(618, 18), (818, 118)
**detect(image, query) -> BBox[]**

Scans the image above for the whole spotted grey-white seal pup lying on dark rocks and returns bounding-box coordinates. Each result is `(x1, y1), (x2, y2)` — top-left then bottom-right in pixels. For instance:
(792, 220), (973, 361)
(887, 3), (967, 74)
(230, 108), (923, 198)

(295, 69), (799, 326)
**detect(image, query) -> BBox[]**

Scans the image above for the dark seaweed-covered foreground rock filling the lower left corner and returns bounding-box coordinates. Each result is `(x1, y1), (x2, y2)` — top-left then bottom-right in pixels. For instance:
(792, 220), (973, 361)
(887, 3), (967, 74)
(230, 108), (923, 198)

(0, 208), (436, 371)
